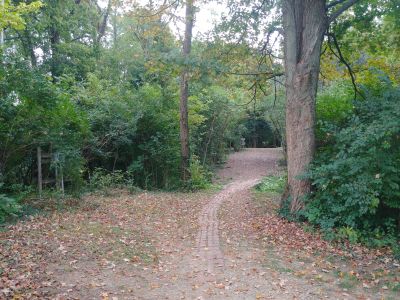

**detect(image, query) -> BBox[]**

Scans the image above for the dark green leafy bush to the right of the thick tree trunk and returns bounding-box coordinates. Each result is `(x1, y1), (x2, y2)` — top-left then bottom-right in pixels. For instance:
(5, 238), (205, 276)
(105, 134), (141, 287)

(303, 83), (400, 242)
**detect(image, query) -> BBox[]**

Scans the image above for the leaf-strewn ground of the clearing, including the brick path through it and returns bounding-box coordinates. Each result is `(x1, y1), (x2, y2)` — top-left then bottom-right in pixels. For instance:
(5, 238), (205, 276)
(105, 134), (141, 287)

(0, 149), (400, 300)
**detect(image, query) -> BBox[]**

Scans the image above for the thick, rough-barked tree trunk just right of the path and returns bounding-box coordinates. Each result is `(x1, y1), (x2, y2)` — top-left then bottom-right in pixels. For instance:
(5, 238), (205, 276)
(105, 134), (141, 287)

(283, 0), (328, 213)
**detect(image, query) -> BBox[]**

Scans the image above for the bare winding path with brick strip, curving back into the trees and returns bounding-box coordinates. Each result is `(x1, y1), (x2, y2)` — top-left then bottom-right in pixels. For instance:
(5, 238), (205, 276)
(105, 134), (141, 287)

(122, 149), (281, 299)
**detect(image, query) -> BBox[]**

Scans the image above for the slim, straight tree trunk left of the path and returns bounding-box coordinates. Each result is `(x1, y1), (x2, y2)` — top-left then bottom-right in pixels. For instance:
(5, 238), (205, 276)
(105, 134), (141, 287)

(180, 0), (194, 181)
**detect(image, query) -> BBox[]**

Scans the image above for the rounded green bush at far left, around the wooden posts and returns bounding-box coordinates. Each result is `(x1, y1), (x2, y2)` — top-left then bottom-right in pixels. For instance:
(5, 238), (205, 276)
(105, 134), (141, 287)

(0, 63), (88, 191)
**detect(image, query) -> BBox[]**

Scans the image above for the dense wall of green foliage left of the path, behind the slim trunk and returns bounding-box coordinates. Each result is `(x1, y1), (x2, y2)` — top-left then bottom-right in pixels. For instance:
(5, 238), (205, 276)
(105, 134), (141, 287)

(0, 0), (276, 206)
